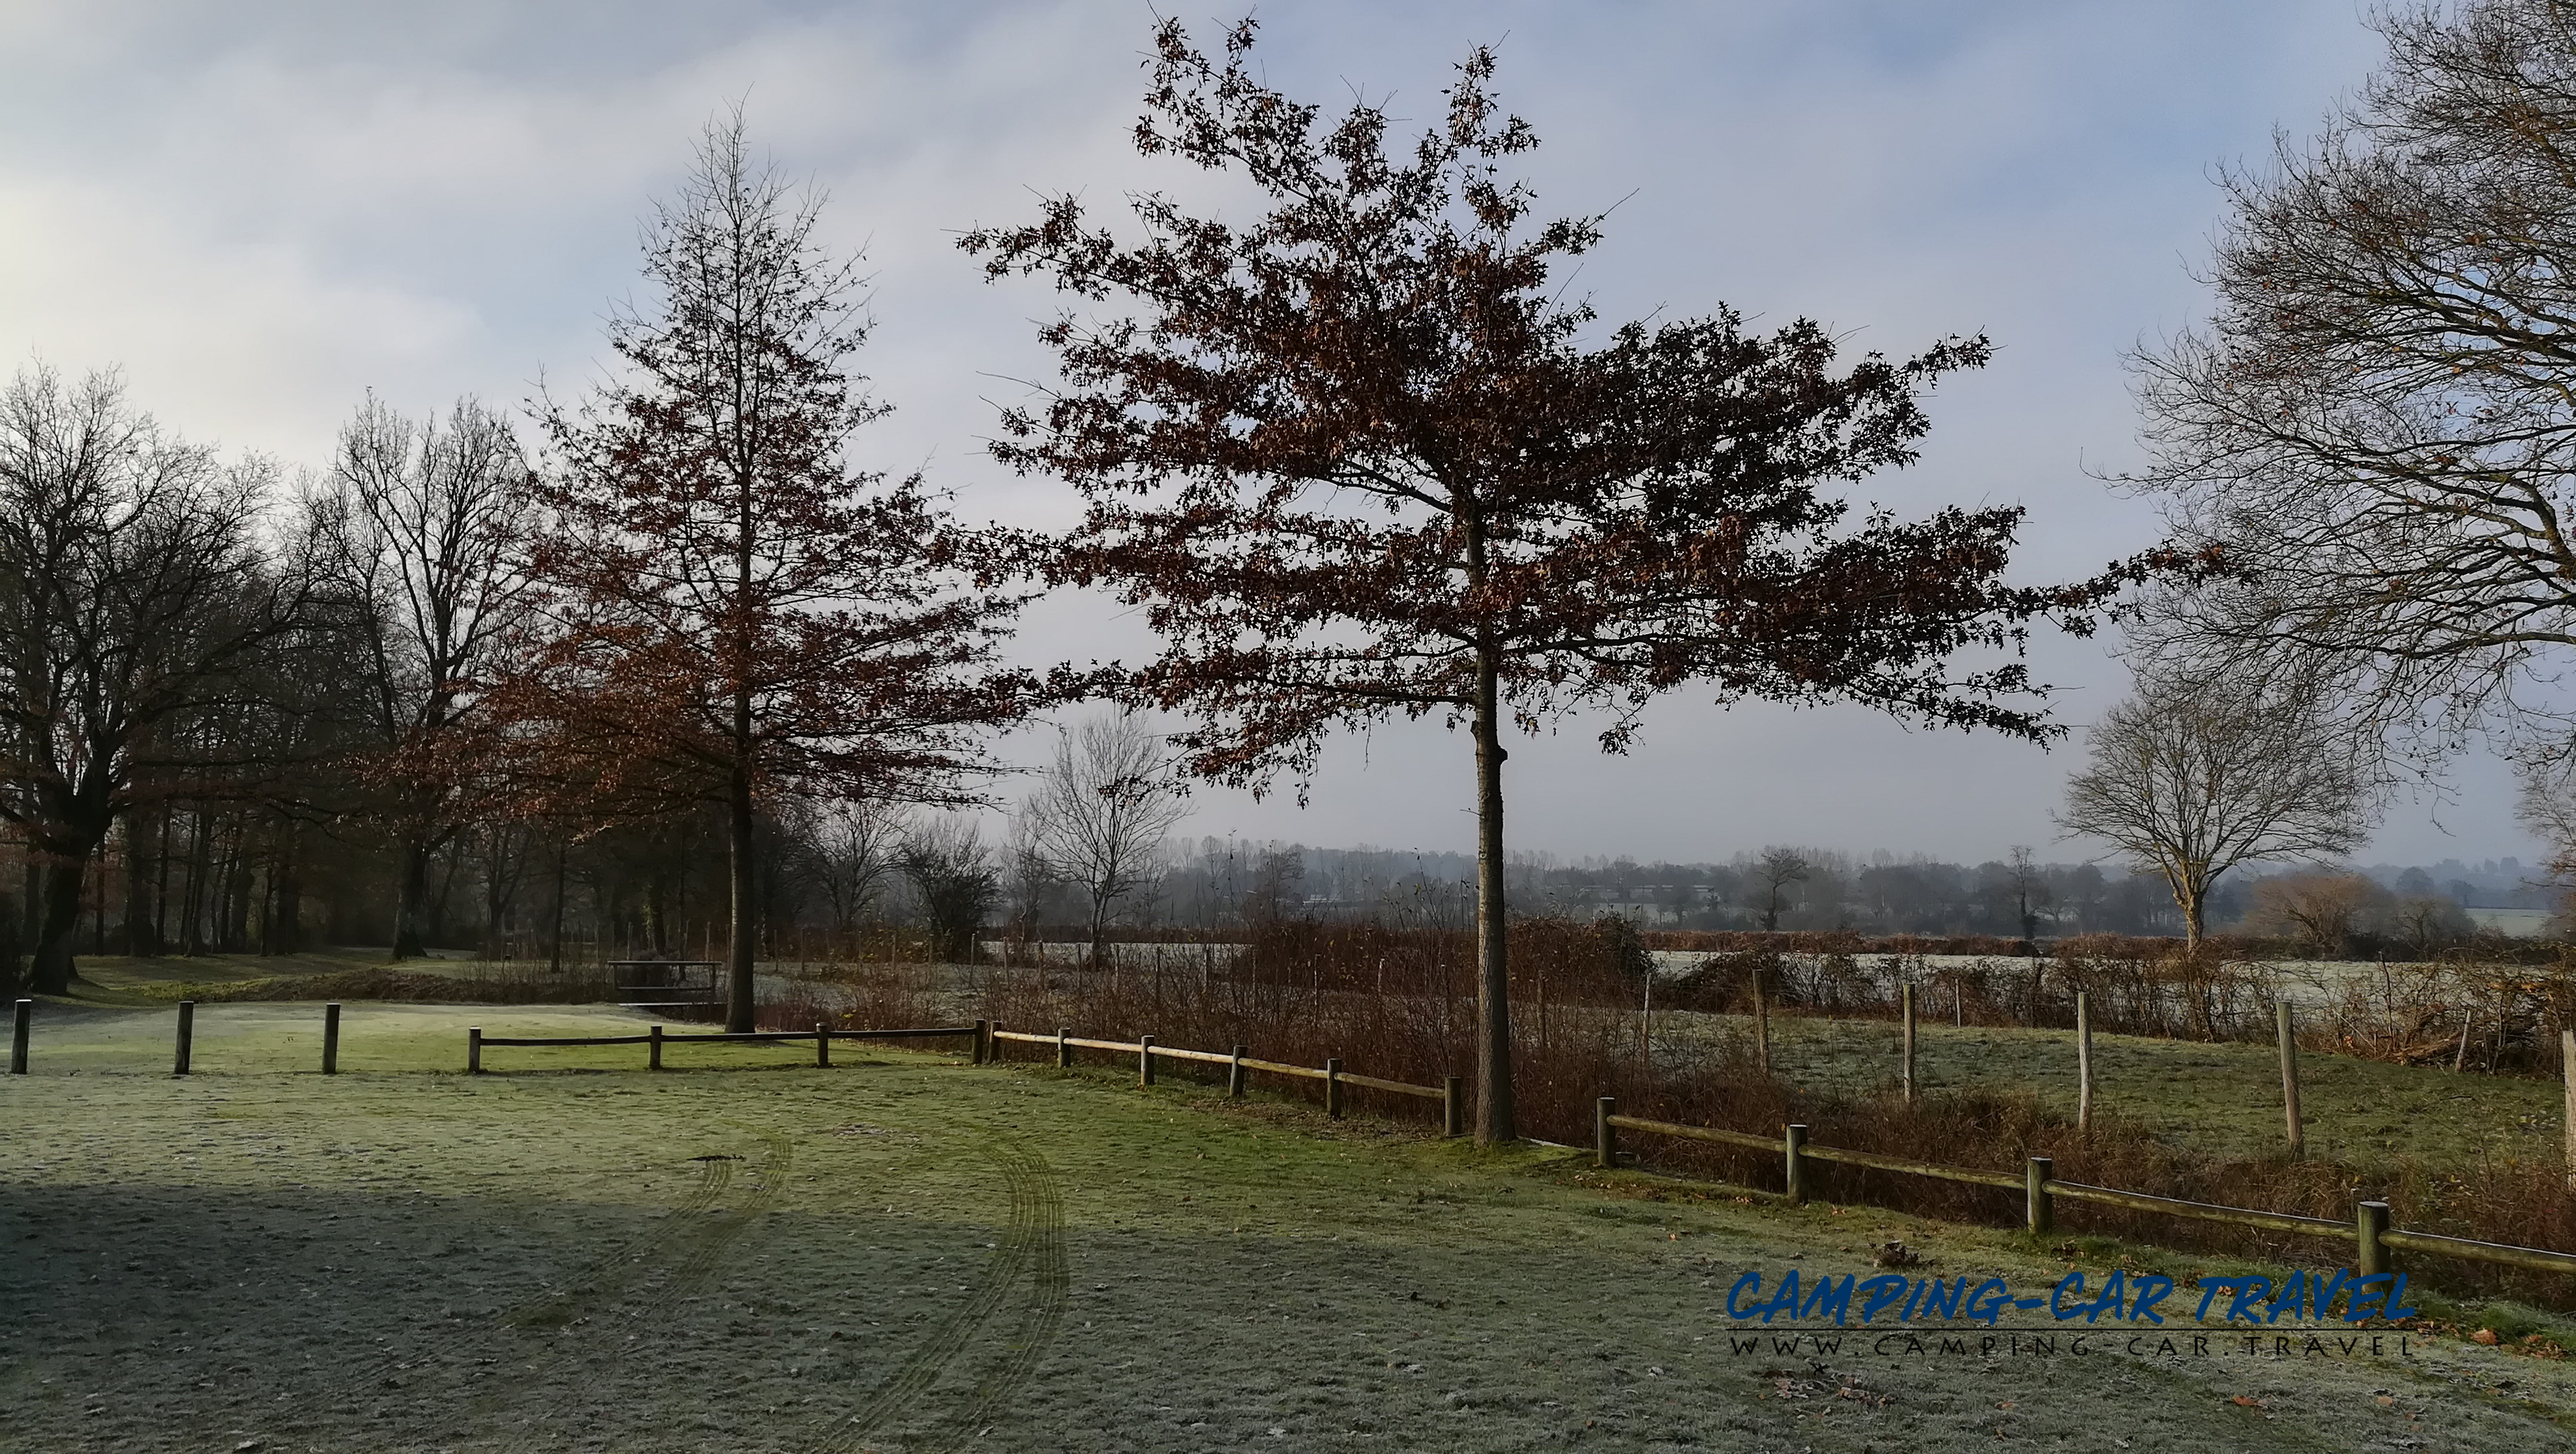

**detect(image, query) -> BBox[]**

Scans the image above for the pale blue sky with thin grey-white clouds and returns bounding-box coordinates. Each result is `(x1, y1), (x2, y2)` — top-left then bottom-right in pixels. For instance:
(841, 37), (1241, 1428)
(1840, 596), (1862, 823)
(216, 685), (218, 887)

(0, 0), (2542, 862)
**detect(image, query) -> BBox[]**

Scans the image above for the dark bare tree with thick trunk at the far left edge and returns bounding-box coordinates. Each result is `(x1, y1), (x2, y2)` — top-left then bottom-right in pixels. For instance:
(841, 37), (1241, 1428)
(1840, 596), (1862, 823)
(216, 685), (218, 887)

(0, 368), (317, 993)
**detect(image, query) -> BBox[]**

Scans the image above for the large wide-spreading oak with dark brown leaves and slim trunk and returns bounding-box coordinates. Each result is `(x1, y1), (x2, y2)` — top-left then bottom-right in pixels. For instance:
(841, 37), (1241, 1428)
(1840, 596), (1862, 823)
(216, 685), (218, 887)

(963, 21), (2107, 1142)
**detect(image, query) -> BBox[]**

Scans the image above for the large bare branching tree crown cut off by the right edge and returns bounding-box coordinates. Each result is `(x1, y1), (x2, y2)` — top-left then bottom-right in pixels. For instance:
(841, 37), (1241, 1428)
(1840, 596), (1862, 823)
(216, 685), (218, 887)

(2133, 0), (2576, 752)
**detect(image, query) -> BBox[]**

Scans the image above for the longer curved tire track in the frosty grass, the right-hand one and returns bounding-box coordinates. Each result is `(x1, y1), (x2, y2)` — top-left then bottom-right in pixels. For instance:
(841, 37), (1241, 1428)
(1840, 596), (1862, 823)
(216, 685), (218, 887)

(806, 1140), (1072, 1454)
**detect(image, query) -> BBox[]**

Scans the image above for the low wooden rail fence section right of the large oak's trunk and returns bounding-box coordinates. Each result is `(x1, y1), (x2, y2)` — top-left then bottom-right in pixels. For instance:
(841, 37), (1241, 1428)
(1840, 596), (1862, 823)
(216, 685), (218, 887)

(1592, 1096), (2576, 1274)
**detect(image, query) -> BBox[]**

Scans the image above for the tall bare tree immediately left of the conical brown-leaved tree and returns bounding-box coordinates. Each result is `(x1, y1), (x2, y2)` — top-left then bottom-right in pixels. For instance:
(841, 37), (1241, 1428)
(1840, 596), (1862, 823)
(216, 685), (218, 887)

(319, 397), (530, 960)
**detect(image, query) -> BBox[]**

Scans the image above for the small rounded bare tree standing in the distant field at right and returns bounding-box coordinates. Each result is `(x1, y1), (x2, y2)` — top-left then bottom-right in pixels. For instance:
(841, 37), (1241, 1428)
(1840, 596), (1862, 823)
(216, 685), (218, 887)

(2058, 680), (2373, 944)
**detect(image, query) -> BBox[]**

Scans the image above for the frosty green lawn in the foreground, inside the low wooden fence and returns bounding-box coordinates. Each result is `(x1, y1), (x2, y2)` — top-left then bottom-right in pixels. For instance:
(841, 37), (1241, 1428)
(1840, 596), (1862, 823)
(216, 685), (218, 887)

(0, 1004), (2576, 1454)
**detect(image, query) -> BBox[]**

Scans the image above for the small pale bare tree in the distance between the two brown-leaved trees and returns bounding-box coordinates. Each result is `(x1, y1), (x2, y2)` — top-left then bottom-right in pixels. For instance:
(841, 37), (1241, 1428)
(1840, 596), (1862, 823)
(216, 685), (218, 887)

(1022, 713), (1187, 965)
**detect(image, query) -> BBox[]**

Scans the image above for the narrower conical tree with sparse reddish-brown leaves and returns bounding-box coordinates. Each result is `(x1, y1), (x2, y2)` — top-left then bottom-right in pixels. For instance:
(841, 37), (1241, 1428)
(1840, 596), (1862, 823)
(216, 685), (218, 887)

(517, 116), (1035, 1029)
